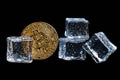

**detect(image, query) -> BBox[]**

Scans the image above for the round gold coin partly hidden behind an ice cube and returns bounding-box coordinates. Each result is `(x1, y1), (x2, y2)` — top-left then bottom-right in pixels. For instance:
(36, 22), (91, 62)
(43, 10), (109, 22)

(21, 22), (58, 60)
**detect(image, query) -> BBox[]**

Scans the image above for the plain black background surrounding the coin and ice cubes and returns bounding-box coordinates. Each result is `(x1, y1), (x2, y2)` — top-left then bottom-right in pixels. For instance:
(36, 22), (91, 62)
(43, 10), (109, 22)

(0, 1), (120, 77)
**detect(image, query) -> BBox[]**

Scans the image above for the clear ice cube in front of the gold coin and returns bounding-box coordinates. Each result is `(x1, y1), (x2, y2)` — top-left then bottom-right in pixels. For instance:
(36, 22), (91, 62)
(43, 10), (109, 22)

(7, 36), (32, 63)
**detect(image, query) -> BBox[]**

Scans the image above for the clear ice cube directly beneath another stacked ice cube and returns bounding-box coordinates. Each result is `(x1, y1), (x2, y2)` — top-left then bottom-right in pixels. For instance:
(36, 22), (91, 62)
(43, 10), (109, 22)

(58, 38), (86, 60)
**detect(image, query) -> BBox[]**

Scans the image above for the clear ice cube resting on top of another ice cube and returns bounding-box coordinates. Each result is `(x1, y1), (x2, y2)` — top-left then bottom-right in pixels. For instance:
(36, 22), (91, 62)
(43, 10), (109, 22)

(65, 18), (89, 40)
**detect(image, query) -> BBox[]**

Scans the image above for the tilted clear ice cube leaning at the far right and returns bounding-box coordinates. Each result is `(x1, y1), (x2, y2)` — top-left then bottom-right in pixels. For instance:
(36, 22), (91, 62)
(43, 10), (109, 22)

(83, 32), (117, 63)
